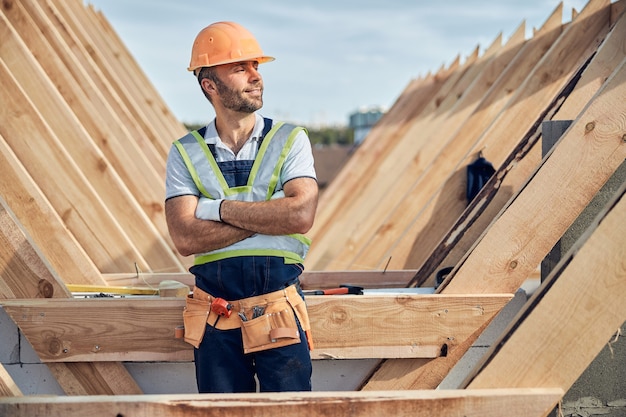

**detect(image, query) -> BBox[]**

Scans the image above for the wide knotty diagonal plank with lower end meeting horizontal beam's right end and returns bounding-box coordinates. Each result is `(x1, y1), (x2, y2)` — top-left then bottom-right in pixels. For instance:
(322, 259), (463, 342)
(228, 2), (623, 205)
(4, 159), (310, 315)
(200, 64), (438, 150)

(442, 55), (626, 294)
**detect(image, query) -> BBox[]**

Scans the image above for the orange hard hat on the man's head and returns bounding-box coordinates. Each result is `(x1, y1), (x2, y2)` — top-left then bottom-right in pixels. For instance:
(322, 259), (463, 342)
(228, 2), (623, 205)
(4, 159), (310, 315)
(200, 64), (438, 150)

(187, 22), (274, 71)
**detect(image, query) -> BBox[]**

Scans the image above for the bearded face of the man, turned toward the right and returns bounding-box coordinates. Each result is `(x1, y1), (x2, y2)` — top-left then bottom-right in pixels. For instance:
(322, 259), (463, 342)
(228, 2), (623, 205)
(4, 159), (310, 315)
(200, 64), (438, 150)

(213, 61), (263, 113)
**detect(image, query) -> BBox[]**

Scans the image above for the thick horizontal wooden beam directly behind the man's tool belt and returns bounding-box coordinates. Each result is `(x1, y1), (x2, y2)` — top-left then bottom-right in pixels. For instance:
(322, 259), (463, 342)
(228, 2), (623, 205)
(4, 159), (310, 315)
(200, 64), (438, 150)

(1, 294), (512, 362)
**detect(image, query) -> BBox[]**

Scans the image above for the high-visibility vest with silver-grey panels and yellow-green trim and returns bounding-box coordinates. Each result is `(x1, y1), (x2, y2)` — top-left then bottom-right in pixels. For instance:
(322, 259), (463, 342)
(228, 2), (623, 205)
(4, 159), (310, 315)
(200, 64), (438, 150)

(174, 119), (311, 265)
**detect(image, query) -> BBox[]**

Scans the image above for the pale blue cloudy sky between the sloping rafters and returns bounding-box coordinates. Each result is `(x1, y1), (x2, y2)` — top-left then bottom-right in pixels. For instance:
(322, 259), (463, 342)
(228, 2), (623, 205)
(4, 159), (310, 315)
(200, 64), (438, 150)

(84, 0), (587, 127)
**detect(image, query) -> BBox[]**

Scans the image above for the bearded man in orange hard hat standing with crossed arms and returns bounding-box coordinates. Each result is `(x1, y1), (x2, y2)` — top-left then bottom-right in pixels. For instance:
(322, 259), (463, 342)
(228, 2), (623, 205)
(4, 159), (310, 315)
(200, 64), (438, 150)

(165, 22), (318, 393)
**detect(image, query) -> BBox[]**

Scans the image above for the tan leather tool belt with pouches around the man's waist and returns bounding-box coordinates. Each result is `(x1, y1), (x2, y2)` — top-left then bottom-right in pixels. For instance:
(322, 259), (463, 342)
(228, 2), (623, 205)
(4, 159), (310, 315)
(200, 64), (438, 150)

(183, 285), (313, 353)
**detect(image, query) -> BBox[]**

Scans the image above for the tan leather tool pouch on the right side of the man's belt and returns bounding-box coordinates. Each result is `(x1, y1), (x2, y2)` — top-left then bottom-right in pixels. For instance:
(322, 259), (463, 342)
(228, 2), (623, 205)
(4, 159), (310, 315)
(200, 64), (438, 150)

(241, 302), (300, 353)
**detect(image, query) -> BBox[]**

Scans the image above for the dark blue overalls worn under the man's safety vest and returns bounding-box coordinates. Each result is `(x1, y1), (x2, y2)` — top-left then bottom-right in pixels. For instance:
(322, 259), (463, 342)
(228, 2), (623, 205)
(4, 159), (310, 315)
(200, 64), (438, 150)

(190, 121), (312, 393)
